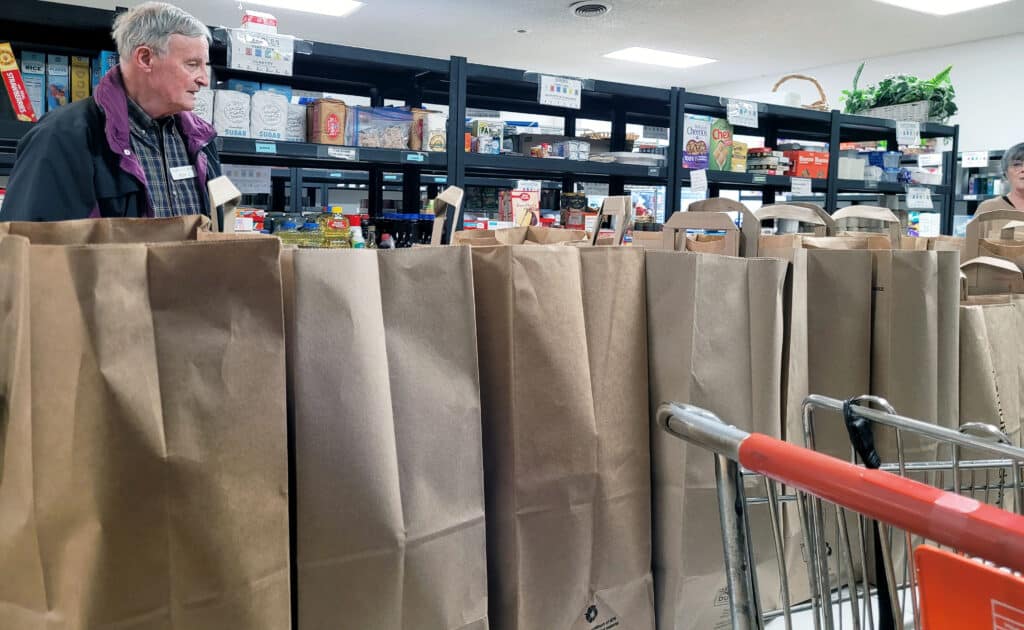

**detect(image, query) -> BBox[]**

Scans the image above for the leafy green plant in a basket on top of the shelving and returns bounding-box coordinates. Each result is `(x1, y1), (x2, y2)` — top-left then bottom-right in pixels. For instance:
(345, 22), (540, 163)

(843, 62), (957, 122)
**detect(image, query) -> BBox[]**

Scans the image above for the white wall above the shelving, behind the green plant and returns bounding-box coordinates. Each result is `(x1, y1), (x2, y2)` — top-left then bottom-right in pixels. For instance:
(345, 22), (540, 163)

(687, 35), (1024, 151)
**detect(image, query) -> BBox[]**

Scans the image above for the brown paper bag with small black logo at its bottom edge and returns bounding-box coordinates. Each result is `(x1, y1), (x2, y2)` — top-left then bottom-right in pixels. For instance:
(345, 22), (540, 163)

(472, 246), (653, 630)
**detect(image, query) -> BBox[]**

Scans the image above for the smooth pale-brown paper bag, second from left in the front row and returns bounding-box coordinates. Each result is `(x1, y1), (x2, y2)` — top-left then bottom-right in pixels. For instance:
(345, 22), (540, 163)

(286, 248), (487, 630)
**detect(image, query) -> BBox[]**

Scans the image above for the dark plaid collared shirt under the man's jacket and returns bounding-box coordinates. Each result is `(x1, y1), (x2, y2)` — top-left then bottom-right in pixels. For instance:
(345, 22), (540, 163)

(128, 98), (203, 217)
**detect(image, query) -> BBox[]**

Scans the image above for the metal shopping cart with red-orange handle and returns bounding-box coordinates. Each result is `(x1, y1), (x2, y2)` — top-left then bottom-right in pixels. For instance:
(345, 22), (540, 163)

(657, 395), (1024, 630)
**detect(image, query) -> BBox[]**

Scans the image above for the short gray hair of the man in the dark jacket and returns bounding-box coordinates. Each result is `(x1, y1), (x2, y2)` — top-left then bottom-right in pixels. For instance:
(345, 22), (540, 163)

(112, 2), (212, 59)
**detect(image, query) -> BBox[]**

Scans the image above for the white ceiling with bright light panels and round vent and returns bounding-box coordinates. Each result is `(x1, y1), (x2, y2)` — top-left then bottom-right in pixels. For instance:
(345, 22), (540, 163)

(65, 0), (1024, 88)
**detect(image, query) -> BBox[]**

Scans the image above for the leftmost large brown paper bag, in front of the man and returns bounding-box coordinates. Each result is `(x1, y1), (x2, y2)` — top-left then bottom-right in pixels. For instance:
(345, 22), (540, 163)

(0, 232), (291, 630)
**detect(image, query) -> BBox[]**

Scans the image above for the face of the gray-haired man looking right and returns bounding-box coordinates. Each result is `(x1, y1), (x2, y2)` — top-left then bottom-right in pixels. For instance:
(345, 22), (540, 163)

(148, 35), (210, 116)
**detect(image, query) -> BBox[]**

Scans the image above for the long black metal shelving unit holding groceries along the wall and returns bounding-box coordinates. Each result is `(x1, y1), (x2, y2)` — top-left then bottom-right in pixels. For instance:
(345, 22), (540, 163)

(0, 0), (958, 234)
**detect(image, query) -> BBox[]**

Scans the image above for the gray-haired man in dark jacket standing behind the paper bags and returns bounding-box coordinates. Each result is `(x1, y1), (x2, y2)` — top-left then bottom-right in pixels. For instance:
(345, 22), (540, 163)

(0, 2), (220, 221)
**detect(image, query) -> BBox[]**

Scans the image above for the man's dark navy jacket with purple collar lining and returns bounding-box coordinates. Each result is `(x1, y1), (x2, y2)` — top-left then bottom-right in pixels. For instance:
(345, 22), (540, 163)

(0, 67), (220, 221)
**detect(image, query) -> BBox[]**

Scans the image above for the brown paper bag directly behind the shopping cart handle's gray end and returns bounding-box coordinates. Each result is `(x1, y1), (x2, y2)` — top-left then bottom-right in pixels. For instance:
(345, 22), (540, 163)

(646, 250), (786, 630)
